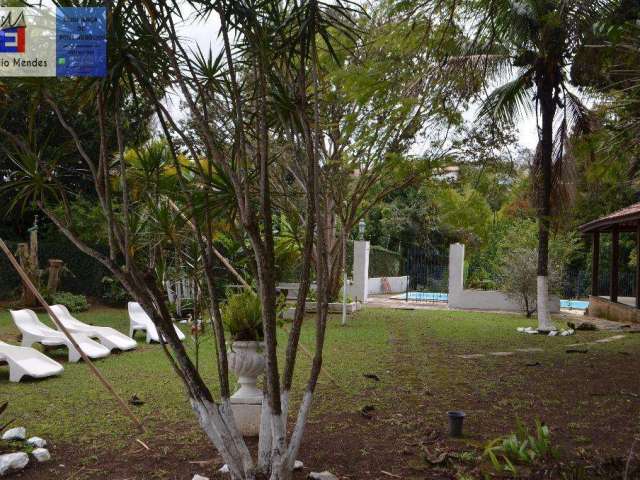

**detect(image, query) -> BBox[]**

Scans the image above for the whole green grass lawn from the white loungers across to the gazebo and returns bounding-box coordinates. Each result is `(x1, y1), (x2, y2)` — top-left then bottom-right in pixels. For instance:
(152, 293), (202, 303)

(0, 308), (640, 478)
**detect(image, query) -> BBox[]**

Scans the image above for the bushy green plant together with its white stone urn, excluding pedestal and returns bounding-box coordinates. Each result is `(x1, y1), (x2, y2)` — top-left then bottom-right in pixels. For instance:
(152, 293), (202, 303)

(222, 289), (265, 403)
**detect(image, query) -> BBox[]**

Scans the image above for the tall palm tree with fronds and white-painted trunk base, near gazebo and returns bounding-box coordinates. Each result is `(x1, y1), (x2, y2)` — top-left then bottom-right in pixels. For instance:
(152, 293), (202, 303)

(477, 0), (615, 331)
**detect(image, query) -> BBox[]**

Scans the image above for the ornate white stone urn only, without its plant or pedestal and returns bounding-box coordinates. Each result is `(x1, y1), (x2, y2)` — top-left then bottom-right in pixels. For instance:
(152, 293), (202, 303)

(227, 342), (265, 403)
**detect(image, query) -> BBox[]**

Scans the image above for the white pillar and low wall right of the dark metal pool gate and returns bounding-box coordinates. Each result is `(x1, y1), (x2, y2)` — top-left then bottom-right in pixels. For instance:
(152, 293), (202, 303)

(449, 243), (560, 313)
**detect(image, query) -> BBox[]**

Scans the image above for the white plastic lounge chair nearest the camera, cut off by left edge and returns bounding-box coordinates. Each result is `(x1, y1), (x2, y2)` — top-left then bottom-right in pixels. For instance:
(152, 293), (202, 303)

(0, 341), (64, 382)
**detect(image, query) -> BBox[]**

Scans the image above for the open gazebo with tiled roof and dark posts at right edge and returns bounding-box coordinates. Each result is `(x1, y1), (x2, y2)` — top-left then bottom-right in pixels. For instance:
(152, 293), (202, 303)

(580, 202), (640, 308)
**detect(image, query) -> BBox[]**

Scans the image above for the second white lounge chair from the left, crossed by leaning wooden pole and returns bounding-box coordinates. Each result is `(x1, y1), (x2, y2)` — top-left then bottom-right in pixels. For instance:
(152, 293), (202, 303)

(10, 308), (109, 363)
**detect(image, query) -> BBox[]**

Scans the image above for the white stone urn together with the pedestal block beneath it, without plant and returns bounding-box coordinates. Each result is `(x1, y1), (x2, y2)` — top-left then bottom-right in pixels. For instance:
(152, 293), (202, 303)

(227, 341), (266, 437)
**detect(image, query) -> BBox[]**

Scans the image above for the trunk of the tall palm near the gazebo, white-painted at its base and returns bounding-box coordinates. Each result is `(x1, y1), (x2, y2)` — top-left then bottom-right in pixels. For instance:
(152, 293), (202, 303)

(537, 72), (556, 332)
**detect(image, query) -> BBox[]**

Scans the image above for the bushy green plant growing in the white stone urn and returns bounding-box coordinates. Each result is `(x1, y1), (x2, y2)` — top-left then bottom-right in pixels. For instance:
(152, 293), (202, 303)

(221, 289), (264, 341)
